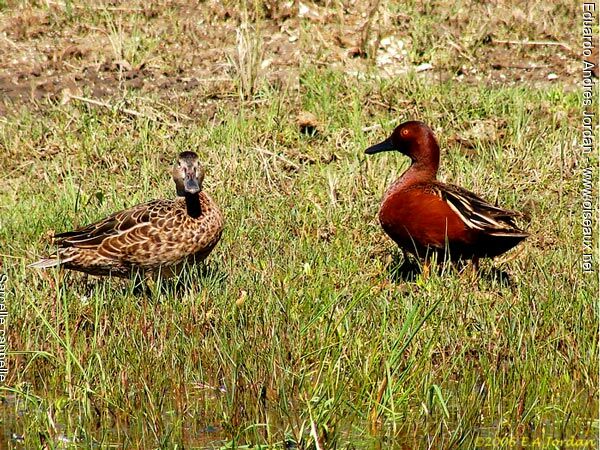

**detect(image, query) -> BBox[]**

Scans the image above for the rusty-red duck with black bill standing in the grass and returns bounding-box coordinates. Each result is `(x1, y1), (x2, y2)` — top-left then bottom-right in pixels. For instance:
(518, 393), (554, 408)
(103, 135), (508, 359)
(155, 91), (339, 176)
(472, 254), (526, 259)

(365, 121), (529, 264)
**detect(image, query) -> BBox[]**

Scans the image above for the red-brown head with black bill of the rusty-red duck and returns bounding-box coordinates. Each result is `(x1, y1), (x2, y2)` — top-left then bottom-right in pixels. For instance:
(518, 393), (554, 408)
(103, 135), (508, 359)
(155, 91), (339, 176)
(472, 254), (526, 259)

(365, 120), (440, 177)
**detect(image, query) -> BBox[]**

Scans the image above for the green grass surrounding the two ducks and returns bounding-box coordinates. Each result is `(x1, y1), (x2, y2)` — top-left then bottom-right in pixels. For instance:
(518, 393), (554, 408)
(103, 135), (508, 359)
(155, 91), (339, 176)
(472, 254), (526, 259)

(0, 0), (599, 448)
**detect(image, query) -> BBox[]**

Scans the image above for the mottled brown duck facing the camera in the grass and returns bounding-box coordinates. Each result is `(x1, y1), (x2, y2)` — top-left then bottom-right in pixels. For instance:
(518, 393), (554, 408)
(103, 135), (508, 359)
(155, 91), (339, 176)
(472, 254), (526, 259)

(30, 152), (223, 278)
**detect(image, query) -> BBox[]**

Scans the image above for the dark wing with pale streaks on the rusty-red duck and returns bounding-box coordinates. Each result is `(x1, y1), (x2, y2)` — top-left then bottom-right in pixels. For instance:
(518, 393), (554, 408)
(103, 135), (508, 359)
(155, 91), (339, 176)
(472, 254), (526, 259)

(434, 183), (529, 237)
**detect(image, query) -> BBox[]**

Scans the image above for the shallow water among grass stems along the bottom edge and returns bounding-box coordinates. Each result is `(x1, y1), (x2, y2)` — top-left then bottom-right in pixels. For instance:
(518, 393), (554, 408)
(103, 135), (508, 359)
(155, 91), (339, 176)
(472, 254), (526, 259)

(0, 394), (600, 450)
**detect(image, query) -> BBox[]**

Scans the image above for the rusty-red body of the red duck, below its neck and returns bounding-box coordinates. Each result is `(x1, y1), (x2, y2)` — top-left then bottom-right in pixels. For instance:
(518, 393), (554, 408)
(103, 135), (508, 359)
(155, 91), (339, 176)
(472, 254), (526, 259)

(379, 182), (527, 260)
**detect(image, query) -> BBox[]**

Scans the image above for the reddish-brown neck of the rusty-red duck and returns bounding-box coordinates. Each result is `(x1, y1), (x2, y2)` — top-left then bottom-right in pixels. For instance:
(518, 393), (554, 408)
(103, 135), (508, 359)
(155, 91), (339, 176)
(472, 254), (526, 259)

(385, 136), (440, 196)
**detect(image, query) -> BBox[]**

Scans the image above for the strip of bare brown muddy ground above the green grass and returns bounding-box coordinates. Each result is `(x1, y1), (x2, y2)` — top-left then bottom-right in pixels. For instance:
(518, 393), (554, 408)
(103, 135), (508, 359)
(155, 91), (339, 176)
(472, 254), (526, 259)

(0, 0), (592, 118)
